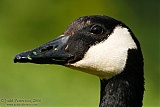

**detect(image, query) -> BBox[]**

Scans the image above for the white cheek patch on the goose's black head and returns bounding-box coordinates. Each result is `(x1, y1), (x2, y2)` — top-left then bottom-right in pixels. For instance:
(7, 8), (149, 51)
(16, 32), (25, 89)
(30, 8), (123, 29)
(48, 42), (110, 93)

(69, 26), (137, 78)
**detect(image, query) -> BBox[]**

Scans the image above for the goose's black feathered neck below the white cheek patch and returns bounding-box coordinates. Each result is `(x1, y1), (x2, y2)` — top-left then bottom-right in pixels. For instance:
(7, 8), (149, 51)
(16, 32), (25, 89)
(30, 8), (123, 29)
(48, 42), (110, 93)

(99, 50), (144, 107)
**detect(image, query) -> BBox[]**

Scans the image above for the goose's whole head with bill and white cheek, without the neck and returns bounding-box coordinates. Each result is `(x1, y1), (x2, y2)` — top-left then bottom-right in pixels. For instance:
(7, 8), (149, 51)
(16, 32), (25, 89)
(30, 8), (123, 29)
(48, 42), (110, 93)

(14, 15), (140, 78)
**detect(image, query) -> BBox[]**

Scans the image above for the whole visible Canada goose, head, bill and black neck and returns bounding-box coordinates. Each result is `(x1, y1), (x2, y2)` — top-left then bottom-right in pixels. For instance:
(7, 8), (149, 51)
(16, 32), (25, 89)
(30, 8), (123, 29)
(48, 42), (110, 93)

(14, 15), (144, 107)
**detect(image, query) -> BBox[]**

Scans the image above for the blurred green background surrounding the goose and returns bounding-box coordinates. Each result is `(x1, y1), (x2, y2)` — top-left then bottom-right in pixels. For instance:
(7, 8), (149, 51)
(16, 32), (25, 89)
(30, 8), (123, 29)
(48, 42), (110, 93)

(0, 0), (160, 107)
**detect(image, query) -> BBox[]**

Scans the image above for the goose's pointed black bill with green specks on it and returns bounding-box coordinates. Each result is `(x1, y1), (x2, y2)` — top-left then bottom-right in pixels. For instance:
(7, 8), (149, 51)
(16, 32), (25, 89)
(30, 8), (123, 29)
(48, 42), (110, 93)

(14, 35), (73, 65)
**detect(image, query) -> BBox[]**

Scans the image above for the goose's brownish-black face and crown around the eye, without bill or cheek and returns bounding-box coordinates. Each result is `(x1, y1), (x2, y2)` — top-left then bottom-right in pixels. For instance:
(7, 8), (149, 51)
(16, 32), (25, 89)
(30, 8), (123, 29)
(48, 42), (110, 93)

(64, 15), (126, 63)
